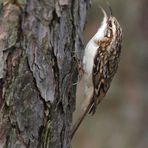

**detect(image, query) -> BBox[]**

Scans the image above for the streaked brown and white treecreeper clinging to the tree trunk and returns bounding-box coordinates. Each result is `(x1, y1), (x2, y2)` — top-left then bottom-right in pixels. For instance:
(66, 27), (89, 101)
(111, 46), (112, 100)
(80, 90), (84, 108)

(71, 7), (122, 139)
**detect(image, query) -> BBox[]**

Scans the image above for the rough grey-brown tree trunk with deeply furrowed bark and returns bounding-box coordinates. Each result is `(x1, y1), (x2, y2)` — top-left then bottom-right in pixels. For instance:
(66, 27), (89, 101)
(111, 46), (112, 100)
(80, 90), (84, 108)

(0, 0), (88, 148)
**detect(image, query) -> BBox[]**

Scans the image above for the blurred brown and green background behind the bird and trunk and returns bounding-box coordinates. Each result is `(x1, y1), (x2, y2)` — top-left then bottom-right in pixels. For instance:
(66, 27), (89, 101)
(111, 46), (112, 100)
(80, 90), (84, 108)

(72, 0), (148, 148)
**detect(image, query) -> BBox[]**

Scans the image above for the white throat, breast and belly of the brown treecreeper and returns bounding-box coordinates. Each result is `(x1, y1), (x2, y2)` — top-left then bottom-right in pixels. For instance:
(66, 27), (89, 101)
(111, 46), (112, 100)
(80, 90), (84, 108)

(83, 17), (107, 97)
